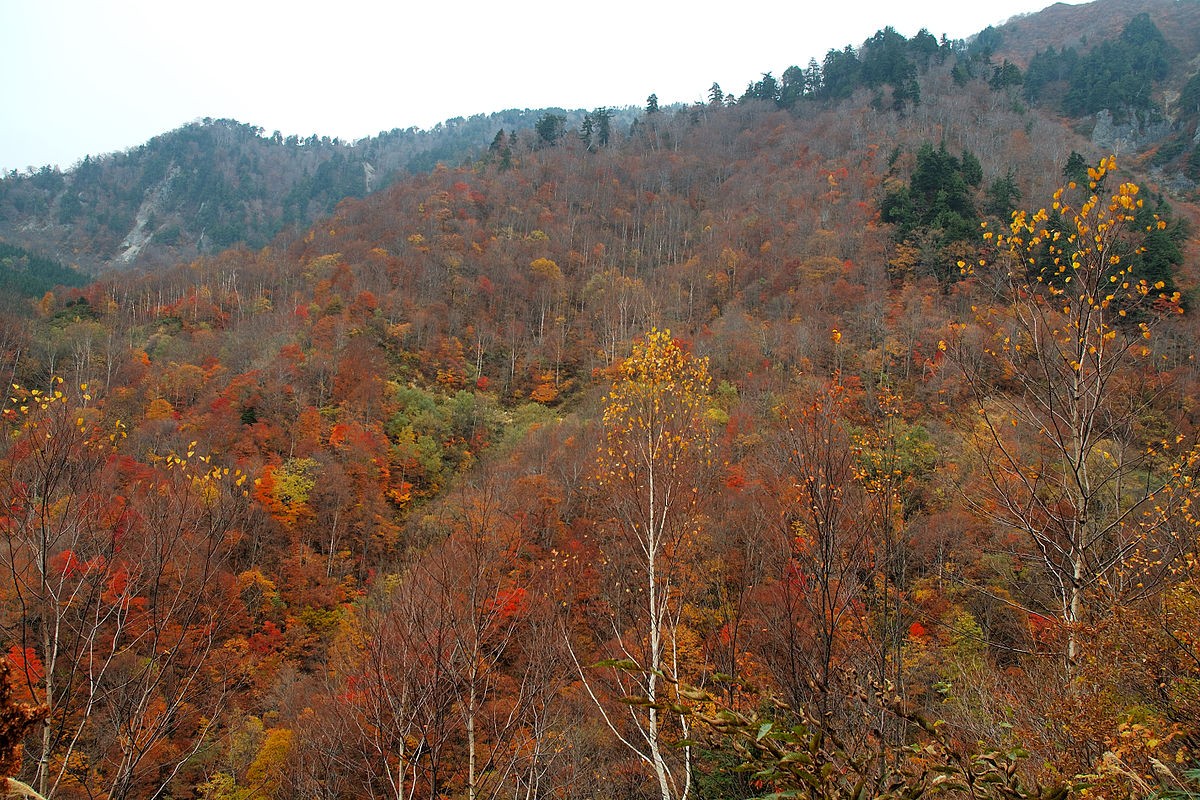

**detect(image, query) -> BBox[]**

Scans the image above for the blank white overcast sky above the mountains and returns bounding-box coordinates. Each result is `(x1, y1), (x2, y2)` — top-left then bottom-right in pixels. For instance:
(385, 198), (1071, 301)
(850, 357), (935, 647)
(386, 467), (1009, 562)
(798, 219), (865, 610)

(0, 0), (1078, 172)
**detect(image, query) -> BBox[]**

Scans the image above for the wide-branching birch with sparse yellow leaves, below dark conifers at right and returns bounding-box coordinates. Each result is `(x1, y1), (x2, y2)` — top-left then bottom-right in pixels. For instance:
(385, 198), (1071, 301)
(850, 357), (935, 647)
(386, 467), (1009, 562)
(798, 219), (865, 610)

(940, 158), (1182, 670)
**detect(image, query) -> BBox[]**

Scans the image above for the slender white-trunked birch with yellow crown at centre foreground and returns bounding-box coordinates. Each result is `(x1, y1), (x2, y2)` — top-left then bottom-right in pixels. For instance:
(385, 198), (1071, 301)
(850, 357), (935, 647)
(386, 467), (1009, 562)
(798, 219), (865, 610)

(584, 329), (712, 800)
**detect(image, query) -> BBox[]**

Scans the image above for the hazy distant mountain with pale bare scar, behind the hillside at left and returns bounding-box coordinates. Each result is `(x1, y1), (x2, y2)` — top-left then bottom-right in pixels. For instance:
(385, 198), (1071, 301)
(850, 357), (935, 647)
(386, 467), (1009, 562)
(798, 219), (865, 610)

(0, 109), (631, 271)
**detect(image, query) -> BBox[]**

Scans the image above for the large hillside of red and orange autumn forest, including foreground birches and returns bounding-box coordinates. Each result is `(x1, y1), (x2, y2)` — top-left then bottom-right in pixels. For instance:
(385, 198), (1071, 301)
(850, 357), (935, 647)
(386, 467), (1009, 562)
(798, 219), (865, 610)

(0, 4), (1200, 800)
